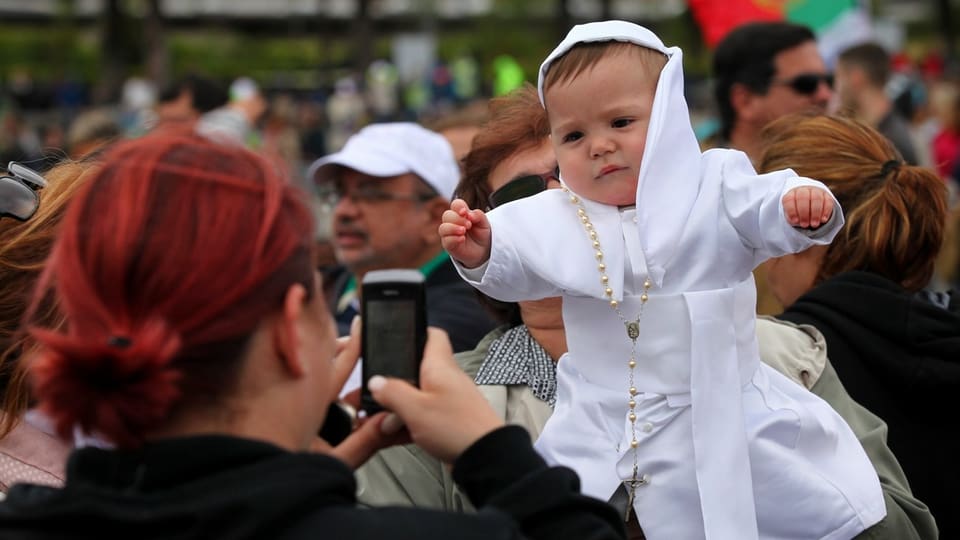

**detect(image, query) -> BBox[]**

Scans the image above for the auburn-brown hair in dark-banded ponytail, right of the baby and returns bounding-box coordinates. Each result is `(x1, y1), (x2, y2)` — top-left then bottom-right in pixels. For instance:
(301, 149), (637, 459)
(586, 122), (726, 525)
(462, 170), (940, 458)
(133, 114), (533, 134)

(760, 115), (947, 292)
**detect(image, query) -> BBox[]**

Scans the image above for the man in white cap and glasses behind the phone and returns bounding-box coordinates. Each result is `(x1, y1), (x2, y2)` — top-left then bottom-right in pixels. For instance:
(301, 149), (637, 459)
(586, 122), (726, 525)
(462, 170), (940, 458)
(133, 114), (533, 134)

(309, 122), (495, 351)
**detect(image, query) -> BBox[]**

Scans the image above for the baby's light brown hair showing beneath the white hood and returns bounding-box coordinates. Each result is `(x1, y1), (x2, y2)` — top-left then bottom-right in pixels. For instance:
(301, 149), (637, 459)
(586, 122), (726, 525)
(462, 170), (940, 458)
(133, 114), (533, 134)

(543, 41), (667, 106)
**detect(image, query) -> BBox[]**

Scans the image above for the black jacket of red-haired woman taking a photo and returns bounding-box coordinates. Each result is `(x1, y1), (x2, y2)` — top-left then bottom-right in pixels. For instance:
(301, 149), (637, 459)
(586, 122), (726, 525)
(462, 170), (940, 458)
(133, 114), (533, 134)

(0, 426), (625, 540)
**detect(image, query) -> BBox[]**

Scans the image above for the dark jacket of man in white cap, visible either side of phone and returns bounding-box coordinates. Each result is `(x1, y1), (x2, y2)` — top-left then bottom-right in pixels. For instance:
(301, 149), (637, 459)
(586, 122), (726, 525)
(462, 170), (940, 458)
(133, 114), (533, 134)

(324, 259), (498, 352)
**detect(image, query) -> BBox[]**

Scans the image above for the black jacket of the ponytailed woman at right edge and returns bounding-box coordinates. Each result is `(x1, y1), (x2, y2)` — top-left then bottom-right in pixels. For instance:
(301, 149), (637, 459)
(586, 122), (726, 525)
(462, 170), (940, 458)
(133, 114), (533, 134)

(781, 272), (960, 538)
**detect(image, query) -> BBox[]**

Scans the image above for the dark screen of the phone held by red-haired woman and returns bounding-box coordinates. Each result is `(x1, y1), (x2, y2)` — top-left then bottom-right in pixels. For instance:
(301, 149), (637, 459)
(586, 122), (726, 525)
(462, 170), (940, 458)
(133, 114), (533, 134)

(363, 300), (418, 381)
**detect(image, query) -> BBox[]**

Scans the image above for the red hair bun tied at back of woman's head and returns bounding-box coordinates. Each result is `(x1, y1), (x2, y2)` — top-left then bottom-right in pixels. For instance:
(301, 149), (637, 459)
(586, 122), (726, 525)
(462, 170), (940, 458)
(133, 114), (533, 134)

(31, 319), (181, 447)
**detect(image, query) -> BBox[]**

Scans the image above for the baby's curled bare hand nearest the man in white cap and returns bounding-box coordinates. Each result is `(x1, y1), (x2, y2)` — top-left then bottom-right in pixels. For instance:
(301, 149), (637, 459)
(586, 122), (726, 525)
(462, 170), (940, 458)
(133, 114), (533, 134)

(440, 199), (490, 268)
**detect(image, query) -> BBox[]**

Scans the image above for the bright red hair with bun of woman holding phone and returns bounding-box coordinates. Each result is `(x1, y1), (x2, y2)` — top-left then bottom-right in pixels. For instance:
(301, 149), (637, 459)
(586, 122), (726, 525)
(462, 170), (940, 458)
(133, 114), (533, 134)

(25, 135), (313, 446)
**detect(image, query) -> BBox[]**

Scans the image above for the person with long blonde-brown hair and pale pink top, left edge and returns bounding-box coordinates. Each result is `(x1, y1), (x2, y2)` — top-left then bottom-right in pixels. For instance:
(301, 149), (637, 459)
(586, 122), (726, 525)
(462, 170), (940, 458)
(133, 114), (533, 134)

(0, 161), (96, 493)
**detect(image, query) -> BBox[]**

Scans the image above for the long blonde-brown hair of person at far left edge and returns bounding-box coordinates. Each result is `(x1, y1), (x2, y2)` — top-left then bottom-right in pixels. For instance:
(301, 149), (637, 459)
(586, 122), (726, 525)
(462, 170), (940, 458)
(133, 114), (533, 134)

(0, 161), (95, 438)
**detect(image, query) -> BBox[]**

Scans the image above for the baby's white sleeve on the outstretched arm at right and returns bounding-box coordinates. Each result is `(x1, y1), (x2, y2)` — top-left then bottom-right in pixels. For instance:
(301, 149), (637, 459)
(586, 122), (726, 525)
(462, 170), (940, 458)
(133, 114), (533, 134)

(721, 153), (844, 263)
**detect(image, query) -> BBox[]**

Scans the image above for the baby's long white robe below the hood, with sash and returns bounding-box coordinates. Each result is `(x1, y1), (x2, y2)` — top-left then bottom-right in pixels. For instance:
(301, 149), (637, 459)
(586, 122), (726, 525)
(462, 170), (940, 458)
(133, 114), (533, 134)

(461, 150), (886, 540)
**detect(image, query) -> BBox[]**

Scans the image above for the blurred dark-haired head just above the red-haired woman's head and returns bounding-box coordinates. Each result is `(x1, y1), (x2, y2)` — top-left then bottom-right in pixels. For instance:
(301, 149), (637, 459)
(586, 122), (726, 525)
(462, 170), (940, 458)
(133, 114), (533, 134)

(156, 74), (229, 128)
